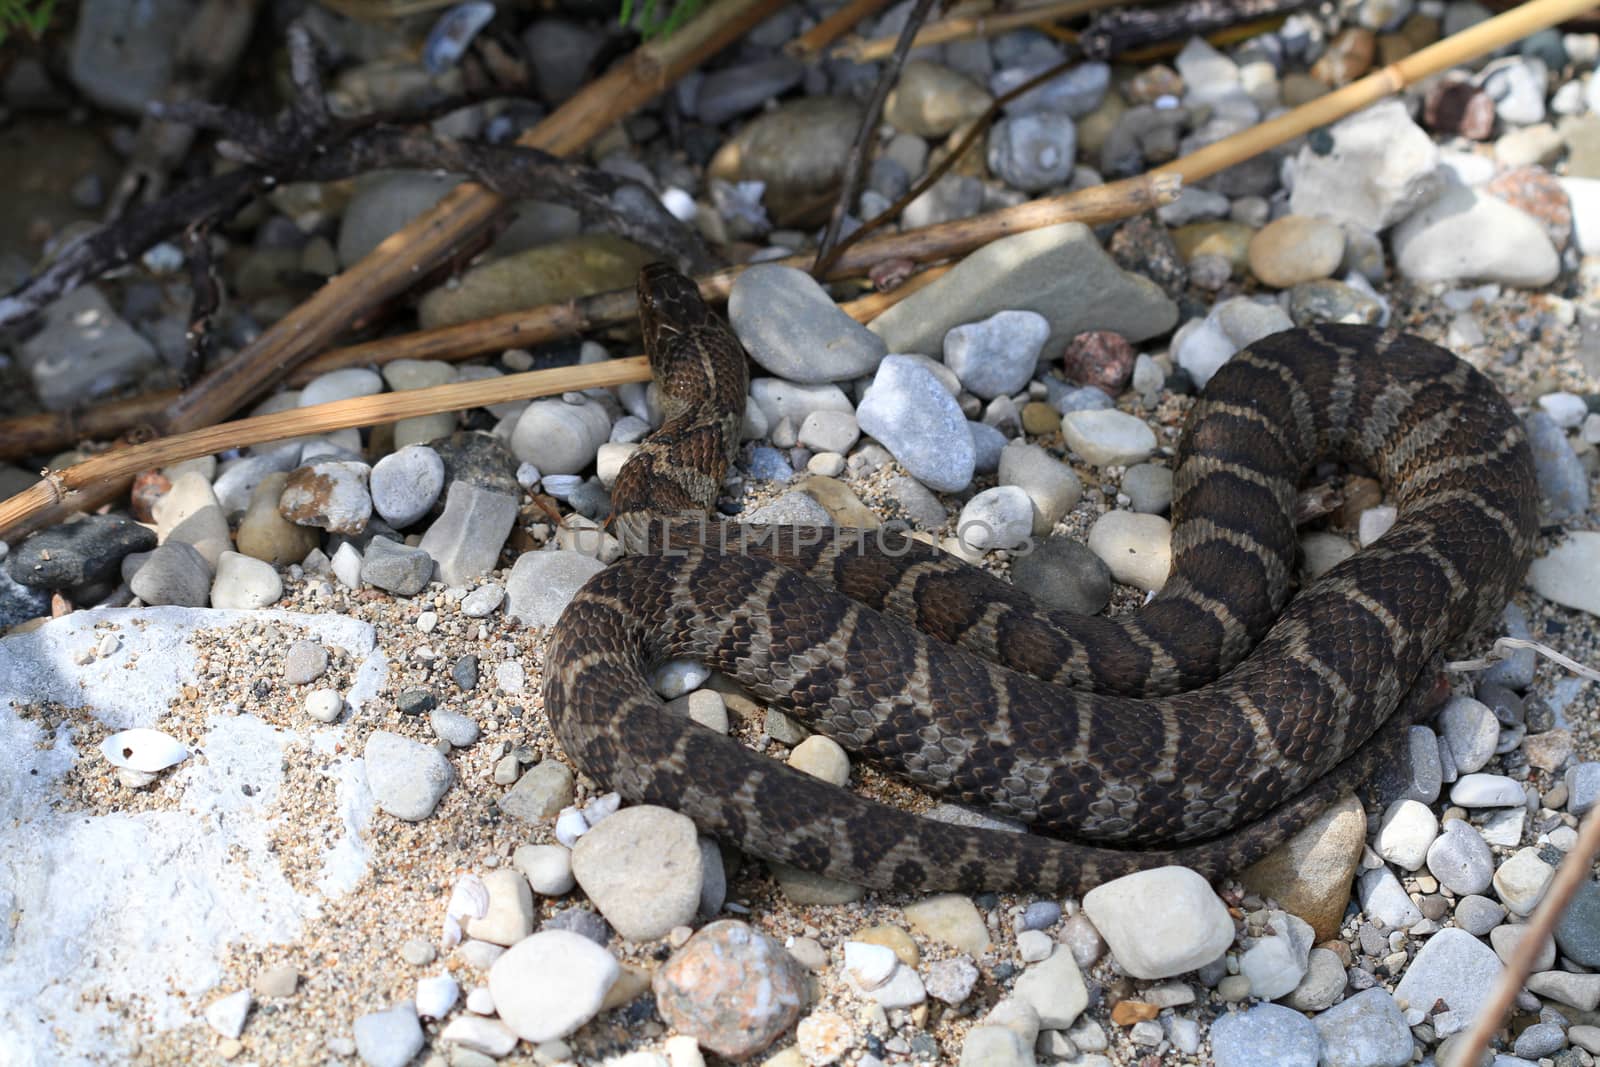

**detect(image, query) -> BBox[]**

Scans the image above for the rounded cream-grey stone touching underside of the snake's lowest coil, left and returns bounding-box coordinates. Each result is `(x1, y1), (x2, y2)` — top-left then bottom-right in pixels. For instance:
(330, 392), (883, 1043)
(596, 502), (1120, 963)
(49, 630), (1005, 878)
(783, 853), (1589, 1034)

(573, 805), (702, 942)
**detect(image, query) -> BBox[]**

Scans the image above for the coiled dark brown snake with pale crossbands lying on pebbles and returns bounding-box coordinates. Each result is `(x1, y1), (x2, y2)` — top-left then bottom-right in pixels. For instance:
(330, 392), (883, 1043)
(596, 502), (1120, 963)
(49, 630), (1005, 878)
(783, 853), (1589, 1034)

(544, 266), (1538, 893)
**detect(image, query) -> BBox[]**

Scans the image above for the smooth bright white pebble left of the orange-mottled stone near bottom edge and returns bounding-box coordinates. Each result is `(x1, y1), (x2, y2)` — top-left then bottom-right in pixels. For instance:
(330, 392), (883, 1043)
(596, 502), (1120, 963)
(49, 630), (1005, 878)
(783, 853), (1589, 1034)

(490, 929), (621, 1043)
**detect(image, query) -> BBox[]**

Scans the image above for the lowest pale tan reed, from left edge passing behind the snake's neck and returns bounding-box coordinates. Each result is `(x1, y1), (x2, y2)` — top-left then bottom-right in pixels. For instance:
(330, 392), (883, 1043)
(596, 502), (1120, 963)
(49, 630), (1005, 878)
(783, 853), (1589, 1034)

(0, 267), (947, 541)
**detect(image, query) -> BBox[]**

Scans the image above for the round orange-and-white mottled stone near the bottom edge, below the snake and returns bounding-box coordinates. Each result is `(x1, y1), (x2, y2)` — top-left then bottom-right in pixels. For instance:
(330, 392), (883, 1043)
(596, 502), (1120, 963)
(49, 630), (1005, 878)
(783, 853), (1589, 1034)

(649, 920), (806, 1061)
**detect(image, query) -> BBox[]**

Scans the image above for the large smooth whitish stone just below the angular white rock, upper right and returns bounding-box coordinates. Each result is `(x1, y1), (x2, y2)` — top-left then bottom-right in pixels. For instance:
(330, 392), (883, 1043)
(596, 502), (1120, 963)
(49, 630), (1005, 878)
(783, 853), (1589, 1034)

(1392, 186), (1560, 288)
